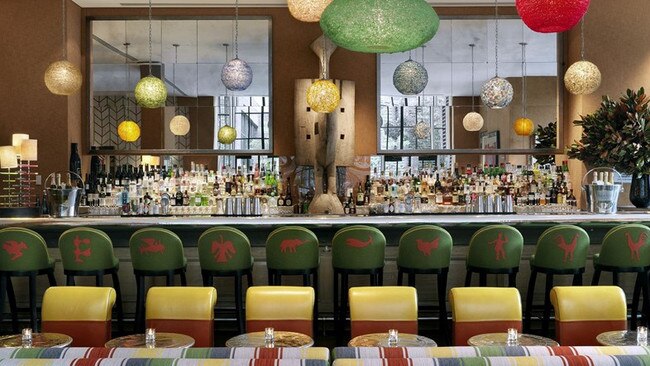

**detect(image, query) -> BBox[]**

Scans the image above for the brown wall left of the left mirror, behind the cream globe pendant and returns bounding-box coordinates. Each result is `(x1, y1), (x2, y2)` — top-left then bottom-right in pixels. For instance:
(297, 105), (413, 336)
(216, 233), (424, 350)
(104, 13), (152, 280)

(0, 0), (83, 179)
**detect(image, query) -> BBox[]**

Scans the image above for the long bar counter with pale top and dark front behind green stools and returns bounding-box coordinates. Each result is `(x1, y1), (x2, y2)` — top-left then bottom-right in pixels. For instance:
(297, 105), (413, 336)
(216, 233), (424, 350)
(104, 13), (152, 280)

(0, 211), (650, 315)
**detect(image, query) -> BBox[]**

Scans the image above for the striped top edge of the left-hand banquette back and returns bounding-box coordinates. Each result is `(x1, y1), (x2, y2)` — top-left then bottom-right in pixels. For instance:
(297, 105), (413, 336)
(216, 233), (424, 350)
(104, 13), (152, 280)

(0, 347), (330, 361)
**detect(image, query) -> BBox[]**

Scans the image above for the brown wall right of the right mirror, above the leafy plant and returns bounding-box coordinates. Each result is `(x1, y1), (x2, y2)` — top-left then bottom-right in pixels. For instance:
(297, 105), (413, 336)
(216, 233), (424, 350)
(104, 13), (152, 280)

(564, 0), (650, 206)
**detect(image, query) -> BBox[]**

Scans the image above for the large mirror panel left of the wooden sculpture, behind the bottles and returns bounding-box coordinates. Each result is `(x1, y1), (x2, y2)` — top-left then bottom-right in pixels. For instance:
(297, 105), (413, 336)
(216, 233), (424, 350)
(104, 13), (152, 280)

(89, 18), (273, 155)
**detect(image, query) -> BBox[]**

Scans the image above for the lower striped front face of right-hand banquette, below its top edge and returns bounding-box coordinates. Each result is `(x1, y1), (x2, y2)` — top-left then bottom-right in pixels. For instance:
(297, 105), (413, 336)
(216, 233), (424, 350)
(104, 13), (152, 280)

(332, 355), (650, 366)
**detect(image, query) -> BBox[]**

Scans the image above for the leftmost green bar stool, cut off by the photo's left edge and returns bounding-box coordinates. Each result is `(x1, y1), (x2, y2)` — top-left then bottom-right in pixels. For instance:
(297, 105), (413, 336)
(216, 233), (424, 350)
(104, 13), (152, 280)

(0, 227), (56, 333)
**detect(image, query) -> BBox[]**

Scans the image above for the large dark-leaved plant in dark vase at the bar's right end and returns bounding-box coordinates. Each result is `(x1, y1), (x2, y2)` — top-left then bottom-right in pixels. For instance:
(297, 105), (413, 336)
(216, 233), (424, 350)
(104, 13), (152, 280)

(567, 88), (650, 208)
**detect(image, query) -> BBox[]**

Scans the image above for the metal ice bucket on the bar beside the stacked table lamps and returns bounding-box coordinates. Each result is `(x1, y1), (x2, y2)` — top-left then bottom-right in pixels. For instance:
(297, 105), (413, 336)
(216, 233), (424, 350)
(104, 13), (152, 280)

(45, 172), (83, 217)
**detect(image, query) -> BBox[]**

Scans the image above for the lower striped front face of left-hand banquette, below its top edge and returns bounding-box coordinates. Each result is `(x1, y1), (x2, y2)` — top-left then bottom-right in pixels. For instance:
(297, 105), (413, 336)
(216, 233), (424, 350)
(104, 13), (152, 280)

(0, 358), (328, 366)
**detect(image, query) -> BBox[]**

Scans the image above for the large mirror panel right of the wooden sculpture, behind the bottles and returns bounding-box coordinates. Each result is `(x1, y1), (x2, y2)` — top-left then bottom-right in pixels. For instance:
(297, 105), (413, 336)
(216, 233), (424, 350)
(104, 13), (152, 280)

(378, 18), (561, 163)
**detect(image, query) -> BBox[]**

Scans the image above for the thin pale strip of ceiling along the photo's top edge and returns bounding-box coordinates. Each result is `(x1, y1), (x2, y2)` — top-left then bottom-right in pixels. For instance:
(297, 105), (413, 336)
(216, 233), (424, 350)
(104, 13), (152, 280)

(72, 0), (514, 8)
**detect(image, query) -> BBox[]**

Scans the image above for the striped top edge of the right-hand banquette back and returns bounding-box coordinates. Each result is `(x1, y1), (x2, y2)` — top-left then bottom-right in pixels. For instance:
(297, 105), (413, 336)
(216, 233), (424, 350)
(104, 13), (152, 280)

(332, 346), (650, 359)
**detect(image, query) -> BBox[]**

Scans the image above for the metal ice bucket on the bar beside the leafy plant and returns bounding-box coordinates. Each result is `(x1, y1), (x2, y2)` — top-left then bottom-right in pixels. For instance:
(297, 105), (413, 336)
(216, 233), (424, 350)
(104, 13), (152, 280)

(582, 168), (623, 214)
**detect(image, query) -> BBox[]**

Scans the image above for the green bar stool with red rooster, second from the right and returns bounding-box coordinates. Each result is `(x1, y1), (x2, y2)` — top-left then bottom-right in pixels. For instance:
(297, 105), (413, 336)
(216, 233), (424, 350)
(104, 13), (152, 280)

(524, 225), (589, 334)
